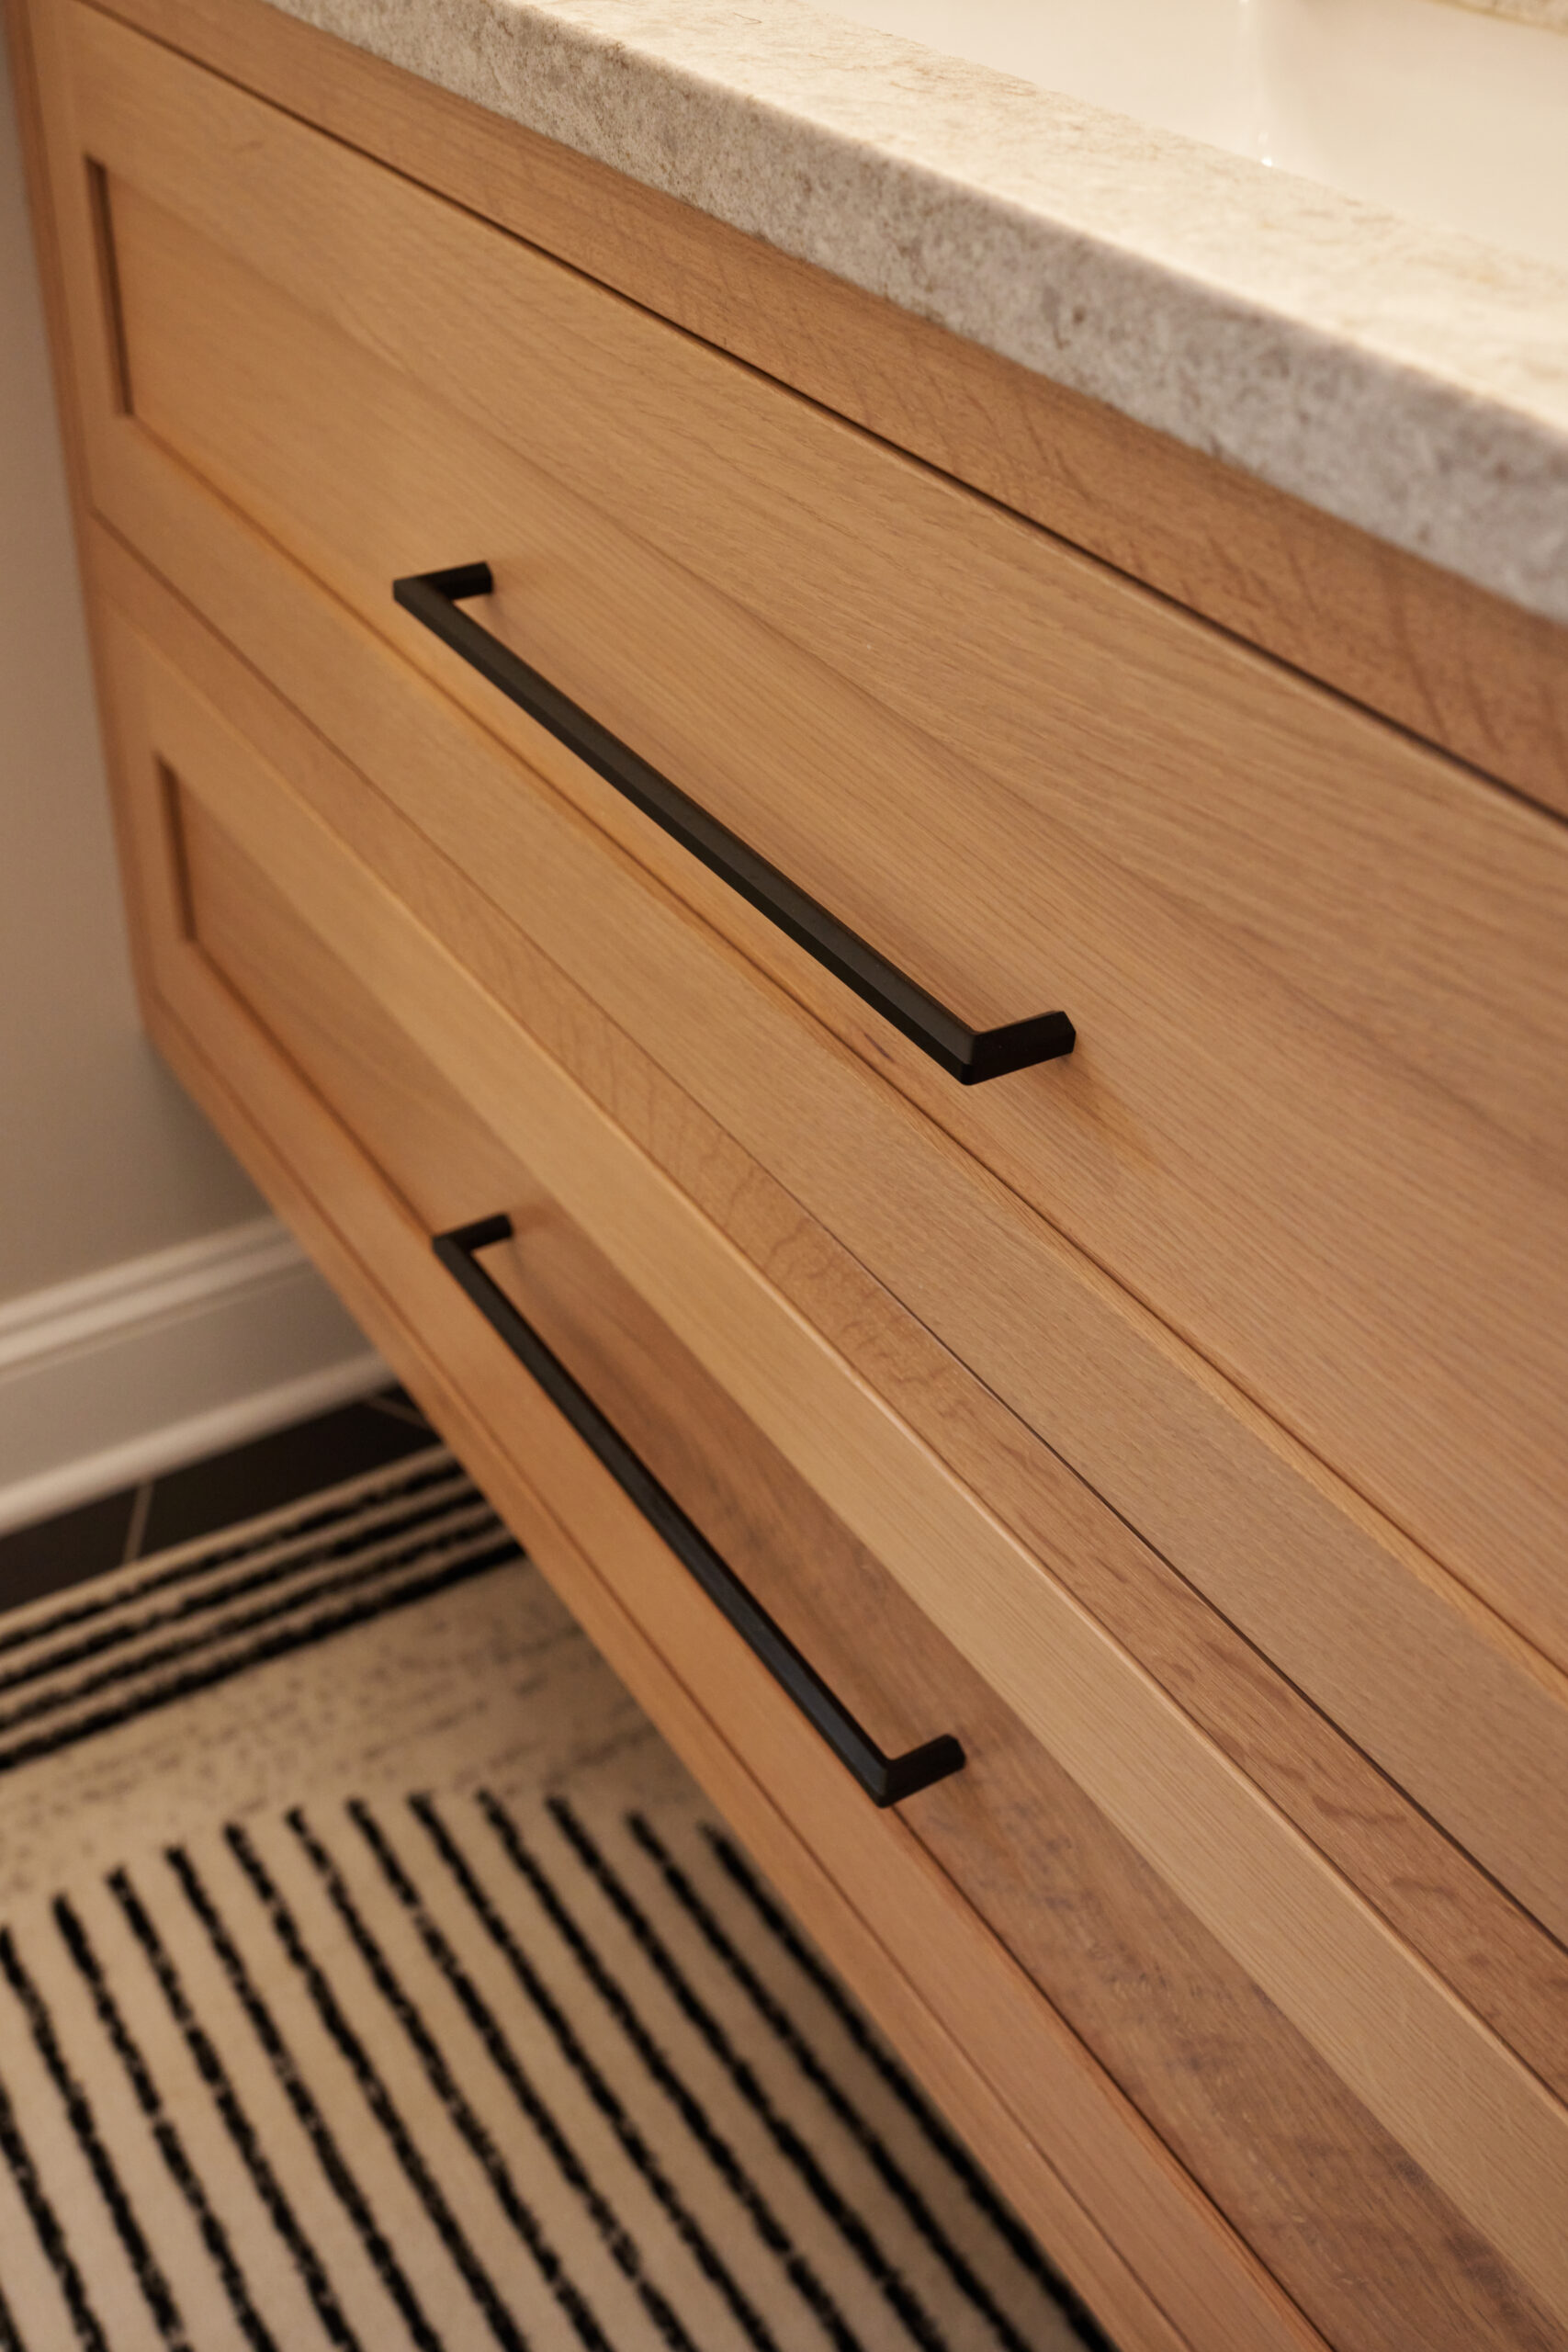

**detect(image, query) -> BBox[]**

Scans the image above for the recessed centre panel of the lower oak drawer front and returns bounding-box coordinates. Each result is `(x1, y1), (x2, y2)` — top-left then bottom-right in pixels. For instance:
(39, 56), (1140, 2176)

(125, 630), (1568, 2352)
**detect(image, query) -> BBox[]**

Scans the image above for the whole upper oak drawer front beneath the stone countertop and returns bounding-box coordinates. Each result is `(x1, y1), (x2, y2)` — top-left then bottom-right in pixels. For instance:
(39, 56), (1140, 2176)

(30, 5), (1568, 1966)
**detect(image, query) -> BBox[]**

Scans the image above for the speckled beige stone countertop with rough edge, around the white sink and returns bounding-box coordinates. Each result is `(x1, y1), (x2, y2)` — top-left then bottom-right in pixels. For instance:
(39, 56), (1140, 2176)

(263, 0), (1568, 621)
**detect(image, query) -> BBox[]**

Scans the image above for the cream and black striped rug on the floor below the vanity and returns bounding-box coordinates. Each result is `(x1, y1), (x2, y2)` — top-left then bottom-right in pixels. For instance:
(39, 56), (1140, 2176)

(0, 1449), (1100, 2352)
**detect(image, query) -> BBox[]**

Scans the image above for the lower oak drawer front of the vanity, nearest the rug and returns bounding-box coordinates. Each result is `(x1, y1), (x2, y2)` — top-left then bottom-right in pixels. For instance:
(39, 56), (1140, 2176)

(92, 555), (1568, 2352)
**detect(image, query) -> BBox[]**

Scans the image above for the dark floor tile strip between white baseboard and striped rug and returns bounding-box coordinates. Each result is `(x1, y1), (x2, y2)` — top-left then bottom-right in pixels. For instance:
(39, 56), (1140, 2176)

(0, 1387), (434, 1609)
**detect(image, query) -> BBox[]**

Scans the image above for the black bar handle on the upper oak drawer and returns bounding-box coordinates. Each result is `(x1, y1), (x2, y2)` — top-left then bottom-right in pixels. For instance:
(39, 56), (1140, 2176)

(392, 564), (1077, 1087)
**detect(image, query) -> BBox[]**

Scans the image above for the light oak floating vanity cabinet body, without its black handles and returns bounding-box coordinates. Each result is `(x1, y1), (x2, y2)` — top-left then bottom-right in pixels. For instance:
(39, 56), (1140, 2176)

(12, 0), (1568, 2352)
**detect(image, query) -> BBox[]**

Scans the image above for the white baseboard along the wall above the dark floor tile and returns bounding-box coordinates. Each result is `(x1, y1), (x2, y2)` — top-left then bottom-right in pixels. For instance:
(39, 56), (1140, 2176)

(0, 1216), (392, 1533)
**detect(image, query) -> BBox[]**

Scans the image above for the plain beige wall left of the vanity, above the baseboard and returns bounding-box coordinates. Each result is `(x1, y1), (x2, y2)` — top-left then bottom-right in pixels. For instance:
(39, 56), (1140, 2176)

(0, 42), (261, 1303)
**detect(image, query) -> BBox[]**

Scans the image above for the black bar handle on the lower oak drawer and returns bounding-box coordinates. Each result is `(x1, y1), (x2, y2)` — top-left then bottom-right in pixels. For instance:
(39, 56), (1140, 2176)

(433, 1216), (964, 1804)
